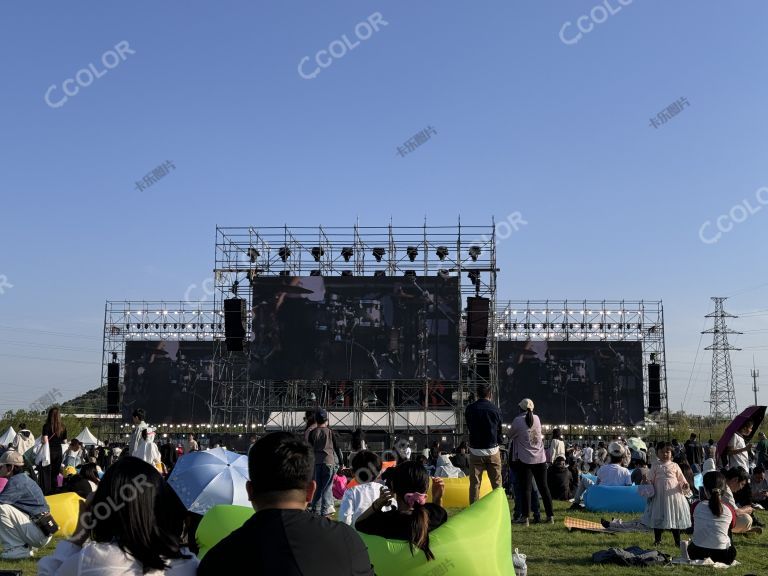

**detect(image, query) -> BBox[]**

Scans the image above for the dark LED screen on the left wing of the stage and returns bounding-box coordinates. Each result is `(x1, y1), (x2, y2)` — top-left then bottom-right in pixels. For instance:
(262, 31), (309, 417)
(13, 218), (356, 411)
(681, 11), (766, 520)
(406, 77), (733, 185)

(122, 340), (213, 424)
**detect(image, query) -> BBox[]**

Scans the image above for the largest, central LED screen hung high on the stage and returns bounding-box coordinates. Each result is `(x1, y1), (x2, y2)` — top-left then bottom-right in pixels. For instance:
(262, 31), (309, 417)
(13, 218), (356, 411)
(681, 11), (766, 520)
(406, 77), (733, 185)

(250, 276), (459, 380)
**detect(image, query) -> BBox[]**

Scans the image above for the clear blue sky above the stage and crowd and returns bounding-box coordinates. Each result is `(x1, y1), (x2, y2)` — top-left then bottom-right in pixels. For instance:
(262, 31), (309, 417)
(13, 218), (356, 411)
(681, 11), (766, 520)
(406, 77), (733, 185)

(0, 0), (768, 413)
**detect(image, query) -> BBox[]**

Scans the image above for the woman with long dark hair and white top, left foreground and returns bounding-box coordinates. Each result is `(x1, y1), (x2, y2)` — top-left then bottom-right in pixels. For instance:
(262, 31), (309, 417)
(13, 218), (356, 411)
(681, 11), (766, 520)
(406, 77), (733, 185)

(37, 456), (198, 576)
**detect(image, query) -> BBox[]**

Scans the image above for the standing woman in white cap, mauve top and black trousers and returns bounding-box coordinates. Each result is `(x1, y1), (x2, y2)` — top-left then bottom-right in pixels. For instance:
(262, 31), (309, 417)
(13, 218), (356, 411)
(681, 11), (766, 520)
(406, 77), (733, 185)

(509, 398), (555, 526)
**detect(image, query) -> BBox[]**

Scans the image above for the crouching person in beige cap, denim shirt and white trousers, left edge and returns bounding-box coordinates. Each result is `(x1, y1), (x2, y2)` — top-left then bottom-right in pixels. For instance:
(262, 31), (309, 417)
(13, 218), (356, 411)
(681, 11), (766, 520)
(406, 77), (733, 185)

(0, 450), (51, 560)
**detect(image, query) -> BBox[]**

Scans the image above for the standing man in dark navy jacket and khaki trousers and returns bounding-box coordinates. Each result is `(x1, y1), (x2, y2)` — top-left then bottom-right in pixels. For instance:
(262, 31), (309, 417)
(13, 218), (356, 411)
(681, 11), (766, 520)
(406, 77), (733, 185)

(464, 386), (501, 504)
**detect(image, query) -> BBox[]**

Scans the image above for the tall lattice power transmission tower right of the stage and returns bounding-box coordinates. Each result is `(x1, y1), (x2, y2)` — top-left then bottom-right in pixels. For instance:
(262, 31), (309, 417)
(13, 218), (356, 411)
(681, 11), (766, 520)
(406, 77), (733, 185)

(702, 297), (741, 420)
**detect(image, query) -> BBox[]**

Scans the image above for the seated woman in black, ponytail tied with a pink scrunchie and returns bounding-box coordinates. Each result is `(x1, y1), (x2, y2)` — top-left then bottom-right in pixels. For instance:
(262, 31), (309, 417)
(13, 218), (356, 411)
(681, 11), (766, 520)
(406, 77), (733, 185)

(355, 462), (448, 561)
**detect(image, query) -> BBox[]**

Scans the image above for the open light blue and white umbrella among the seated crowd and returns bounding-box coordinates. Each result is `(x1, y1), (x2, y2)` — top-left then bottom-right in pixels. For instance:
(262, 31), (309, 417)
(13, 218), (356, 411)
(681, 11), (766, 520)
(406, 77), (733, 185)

(168, 448), (251, 514)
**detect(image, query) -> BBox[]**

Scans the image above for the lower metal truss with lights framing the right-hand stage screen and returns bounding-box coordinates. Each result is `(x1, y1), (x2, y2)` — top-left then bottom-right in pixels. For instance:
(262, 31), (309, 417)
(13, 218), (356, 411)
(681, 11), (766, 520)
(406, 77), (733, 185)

(493, 300), (669, 424)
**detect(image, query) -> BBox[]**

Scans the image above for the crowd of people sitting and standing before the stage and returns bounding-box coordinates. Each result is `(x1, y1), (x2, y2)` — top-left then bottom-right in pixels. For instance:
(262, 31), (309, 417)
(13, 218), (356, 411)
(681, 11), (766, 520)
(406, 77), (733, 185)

(0, 388), (768, 576)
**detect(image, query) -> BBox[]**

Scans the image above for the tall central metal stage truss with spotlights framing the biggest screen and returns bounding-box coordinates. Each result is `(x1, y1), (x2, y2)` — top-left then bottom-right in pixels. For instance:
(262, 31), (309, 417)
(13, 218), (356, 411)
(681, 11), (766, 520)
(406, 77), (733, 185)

(211, 221), (498, 434)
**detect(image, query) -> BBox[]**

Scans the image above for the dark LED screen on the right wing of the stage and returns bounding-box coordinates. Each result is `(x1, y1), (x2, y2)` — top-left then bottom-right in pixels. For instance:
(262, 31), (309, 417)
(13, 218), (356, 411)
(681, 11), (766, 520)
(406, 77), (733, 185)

(498, 341), (644, 425)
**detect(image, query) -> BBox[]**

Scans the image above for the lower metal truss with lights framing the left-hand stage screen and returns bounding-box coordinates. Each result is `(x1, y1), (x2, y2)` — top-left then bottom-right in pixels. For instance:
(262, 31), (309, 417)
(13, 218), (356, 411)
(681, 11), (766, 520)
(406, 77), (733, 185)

(101, 299), (224, 434)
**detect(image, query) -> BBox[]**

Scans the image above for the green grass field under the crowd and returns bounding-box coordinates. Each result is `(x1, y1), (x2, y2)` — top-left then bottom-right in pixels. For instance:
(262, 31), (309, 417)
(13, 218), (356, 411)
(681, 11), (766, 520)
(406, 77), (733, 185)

(0, 502), (768, 576)
